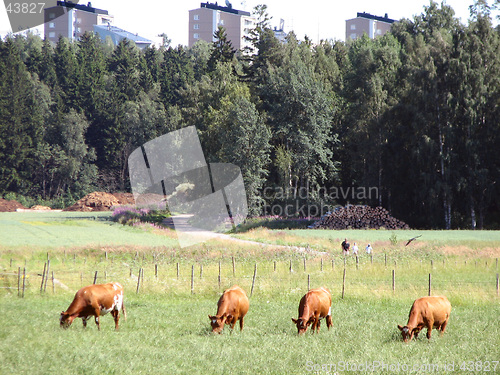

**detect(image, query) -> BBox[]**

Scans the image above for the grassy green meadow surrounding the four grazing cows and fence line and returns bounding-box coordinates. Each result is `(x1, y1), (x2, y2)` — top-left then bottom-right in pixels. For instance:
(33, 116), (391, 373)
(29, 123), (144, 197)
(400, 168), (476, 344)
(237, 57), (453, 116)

(0, 213), (500, 374)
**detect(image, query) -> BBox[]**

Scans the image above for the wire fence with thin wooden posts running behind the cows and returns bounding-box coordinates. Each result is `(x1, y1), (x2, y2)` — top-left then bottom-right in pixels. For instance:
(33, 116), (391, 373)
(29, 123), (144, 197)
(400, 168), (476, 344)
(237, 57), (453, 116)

(0, 252), (499, 298)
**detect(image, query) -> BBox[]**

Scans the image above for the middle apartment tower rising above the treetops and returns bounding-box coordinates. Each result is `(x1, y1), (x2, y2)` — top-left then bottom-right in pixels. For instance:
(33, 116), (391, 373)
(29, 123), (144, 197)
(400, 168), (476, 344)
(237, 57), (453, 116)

(188, 0), (256, 49)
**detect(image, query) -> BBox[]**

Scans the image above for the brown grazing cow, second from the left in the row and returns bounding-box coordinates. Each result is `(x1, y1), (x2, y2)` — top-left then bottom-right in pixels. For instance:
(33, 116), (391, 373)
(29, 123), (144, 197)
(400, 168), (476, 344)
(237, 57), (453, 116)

(208, 285), (250, 333)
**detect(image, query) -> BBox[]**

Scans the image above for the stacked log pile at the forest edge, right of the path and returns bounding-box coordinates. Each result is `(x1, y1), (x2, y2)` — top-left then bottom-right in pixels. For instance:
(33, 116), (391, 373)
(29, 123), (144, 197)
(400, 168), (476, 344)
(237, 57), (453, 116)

(310, 205), (410, 230)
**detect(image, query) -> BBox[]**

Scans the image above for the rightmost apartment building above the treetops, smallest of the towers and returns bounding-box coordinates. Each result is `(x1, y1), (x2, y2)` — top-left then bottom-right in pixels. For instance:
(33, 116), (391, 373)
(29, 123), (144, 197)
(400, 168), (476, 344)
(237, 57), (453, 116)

(345, 12), (395, 41)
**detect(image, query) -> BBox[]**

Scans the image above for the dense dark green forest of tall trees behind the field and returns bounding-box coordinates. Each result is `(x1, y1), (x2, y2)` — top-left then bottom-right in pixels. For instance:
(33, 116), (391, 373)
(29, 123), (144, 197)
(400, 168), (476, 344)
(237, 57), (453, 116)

(0, 0), (500, 229)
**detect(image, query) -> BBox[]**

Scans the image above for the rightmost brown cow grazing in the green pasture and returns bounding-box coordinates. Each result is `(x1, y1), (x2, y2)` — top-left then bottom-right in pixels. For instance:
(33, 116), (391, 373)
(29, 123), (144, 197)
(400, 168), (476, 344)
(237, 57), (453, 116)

(398, 296), (451, 342)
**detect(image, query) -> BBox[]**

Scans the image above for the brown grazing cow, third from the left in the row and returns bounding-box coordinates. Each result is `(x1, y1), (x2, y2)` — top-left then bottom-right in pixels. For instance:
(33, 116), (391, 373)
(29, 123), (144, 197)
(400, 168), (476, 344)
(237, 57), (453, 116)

(292, 288), (332, 335)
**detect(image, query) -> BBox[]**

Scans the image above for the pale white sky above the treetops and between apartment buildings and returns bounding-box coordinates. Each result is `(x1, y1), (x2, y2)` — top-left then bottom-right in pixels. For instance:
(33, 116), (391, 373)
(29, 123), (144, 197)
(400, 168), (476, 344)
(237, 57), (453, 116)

(0, 0), (498, 46)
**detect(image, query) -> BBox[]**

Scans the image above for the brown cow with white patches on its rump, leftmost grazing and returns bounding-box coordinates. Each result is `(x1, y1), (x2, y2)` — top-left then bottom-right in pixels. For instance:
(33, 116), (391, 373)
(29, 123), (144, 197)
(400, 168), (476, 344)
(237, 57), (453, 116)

(60, 283), (127, 330)
